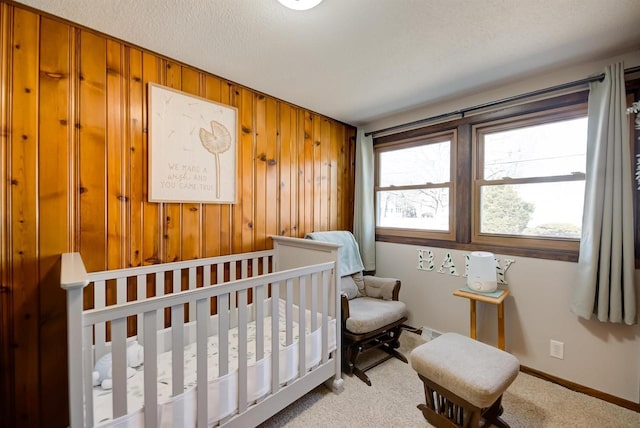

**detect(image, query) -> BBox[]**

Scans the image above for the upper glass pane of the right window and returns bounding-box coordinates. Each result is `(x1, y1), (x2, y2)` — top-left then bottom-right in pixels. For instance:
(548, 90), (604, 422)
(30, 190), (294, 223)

(484, 117), (587, 180)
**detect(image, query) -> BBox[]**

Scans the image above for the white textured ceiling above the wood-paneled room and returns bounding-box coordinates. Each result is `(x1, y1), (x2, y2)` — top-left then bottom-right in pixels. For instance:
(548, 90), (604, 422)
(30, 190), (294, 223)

(15, 0), (640, 125)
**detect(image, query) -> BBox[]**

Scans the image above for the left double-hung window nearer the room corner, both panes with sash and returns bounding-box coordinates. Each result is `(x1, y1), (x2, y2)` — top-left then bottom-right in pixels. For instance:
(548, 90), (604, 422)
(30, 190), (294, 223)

(376, 131), (456, 239)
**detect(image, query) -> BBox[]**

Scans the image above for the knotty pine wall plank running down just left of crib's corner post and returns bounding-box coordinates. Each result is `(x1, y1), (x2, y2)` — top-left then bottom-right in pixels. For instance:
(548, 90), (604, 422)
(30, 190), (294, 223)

(34, 18), (75, 423)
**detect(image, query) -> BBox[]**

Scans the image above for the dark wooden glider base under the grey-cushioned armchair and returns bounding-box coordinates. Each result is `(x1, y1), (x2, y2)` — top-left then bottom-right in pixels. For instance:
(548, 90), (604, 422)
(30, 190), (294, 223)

(342, 317), (408, 386)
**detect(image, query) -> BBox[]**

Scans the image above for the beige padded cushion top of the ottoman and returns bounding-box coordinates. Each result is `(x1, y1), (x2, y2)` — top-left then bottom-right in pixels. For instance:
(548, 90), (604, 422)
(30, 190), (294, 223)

(410, 333), (520, 409)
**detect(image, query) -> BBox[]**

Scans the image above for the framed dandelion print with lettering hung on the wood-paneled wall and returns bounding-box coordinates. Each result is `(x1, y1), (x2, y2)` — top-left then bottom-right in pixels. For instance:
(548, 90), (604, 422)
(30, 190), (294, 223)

(149, 83), (238, 204)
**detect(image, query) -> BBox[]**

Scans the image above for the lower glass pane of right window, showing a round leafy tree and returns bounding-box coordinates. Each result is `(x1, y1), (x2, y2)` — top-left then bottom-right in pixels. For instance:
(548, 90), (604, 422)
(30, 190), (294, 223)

(480, 181), (584, 239)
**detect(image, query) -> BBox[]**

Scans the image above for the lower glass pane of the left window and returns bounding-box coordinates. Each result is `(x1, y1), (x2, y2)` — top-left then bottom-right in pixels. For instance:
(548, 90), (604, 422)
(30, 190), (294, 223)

(377, 188), (449, 231)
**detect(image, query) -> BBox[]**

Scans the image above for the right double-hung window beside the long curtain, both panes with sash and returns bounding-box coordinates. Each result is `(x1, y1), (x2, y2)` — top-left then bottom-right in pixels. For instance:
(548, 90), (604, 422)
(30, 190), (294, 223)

(472, 108), (587, 250)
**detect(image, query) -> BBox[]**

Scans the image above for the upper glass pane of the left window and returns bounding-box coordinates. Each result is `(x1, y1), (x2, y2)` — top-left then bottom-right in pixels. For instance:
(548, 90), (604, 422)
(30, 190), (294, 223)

(378, 141), (451, 187)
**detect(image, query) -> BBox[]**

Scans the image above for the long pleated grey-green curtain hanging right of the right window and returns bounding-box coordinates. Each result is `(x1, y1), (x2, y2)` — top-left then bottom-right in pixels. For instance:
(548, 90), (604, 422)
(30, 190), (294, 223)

(571, 63), (636, 324)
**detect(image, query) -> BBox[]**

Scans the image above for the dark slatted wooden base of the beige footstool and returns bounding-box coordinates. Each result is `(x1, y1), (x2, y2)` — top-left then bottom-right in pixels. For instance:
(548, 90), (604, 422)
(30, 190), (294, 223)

(418, 373), (509, 428)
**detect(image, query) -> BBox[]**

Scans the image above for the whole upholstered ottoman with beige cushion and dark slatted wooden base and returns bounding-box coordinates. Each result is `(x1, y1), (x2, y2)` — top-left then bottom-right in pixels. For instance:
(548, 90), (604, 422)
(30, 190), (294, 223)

(410, 333), (520, 428)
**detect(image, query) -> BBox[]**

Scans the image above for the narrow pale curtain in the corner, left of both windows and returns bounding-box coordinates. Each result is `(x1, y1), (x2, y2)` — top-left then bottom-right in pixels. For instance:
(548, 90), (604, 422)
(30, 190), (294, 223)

(353, 129), (376, 271)
